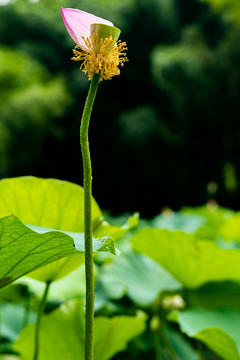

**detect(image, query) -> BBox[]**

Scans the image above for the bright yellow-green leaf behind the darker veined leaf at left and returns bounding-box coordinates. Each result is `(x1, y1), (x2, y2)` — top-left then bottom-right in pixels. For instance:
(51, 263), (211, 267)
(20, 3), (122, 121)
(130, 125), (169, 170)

(0, 177), (129, 281)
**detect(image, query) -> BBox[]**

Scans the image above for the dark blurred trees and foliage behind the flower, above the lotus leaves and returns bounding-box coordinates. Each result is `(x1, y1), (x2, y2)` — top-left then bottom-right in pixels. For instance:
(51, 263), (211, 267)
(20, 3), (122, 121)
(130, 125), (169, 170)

(0, 0), (240, 216)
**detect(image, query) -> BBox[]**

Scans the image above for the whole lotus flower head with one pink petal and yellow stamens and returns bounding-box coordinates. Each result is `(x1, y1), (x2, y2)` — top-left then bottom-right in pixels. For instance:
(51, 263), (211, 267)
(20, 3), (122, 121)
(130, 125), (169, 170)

(61, 8), (127, 80)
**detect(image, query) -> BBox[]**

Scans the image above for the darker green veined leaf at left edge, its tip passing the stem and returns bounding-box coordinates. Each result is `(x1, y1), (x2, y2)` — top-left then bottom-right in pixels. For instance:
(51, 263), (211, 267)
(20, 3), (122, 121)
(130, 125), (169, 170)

(0, 215), (117, 288)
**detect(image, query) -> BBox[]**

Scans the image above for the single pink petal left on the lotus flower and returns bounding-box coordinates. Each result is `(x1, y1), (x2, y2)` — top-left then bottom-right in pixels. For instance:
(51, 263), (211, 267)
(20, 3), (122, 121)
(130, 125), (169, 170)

(61, 8), (114, 48)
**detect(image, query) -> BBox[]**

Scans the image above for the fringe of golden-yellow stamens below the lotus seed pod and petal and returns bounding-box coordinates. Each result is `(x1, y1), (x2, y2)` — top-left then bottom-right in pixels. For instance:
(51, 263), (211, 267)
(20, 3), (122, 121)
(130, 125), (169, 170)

(72, 34), (128, 80)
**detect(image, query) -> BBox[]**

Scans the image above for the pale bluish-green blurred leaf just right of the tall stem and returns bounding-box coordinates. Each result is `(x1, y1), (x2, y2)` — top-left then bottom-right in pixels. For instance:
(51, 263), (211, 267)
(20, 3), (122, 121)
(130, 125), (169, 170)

(97, 250), (181, 306)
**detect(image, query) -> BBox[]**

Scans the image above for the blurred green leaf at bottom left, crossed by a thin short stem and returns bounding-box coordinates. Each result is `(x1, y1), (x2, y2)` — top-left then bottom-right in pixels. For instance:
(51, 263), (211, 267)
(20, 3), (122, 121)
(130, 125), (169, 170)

(13, 301), (85, 360)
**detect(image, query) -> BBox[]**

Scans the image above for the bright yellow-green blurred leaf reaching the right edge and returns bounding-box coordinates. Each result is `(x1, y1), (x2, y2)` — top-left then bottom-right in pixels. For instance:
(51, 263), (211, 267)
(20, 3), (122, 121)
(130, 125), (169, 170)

(132, 228), (240, 288)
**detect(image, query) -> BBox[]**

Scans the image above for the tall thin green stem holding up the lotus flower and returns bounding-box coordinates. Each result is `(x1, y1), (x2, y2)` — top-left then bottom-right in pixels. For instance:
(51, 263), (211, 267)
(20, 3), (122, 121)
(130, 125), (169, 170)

(80, 74), (100, 360)
